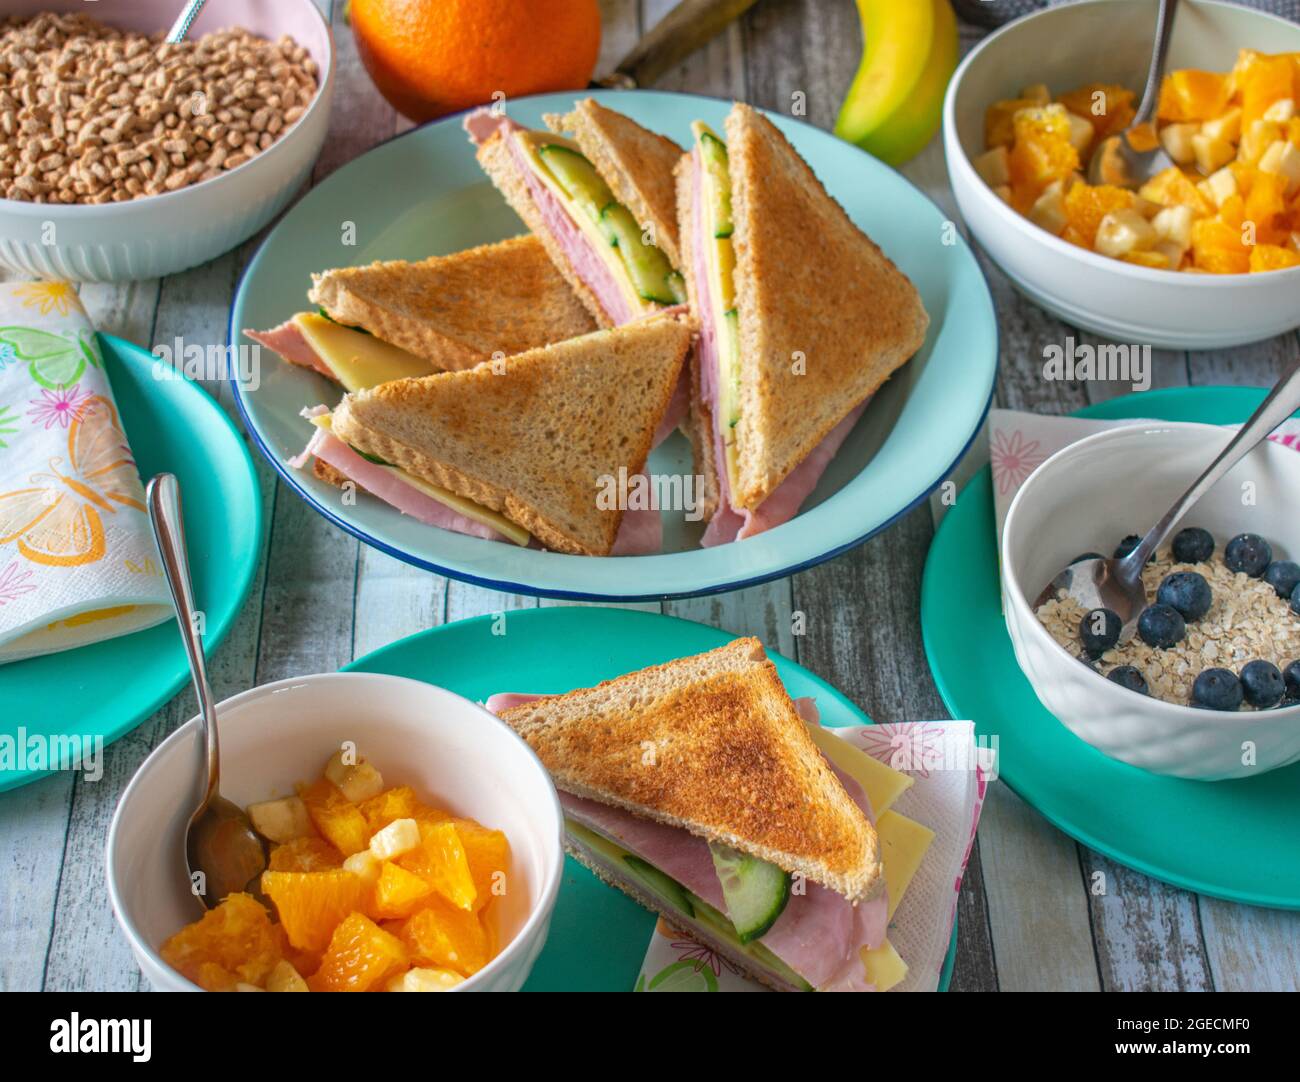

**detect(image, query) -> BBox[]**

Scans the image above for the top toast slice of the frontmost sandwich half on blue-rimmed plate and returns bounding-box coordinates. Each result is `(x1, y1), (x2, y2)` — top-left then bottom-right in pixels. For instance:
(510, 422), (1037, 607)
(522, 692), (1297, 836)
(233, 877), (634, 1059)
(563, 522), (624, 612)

(322, 310), (692, 555)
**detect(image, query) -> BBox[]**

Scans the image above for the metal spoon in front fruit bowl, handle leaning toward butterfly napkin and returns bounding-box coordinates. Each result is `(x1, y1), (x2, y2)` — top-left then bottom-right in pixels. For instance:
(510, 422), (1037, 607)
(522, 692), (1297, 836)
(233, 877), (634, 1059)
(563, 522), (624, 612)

(148, 473), (267, 909)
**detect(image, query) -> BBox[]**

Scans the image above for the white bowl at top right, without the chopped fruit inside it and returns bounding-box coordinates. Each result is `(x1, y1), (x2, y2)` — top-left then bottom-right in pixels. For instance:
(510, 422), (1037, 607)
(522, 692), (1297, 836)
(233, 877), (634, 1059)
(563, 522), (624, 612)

(944, 0), (1300, 350)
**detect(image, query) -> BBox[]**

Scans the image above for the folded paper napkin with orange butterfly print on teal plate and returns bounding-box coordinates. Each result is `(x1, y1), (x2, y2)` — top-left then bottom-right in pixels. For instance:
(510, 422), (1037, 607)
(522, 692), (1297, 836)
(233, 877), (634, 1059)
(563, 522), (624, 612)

(0, 282), (172, 665)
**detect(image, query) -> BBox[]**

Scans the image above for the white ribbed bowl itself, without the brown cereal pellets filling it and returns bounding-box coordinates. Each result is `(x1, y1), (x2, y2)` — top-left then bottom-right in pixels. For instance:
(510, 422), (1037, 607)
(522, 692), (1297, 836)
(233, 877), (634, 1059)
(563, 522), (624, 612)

(0, 0), (334, 282)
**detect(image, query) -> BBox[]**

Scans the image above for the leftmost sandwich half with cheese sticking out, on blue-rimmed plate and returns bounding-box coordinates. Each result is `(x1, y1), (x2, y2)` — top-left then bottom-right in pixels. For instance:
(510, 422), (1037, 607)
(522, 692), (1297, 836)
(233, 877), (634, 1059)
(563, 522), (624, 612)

(246, 235), (594, 390)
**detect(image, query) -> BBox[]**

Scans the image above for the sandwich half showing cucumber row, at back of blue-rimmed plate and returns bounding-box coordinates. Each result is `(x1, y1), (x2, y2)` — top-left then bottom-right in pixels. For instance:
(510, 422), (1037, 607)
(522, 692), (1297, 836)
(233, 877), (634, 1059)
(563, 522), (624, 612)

(464, 99), (685, 326)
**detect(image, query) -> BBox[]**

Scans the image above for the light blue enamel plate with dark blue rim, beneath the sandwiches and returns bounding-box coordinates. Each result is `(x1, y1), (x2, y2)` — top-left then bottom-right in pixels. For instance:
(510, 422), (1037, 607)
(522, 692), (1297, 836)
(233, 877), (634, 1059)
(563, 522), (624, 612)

(230, 91), (997, 601)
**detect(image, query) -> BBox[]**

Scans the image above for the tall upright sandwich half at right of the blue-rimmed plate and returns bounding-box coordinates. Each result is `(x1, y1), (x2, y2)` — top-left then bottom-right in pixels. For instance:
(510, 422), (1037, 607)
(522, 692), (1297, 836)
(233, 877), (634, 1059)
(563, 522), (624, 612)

(676, 103), (928, 545)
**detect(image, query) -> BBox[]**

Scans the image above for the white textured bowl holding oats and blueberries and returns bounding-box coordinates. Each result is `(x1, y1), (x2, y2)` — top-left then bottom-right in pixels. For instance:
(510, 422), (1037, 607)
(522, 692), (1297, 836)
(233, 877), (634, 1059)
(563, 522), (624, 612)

(1001, 423), (1300, 780)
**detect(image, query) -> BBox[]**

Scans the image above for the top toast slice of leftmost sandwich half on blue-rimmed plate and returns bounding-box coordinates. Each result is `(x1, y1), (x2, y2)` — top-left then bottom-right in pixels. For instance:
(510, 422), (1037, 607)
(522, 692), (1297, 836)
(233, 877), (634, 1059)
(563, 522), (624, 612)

(307, 235), (595, 371)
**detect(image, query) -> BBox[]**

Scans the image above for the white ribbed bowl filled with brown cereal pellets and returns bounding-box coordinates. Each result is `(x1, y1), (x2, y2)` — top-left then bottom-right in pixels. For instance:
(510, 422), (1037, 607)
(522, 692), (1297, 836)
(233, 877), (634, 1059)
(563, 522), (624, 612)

(0, 0), (334, 282)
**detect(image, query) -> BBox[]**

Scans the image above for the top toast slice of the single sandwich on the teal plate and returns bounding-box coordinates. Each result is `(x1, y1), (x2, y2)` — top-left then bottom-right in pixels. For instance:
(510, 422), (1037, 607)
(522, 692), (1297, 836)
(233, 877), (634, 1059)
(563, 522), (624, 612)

(501, 639), (884, 901)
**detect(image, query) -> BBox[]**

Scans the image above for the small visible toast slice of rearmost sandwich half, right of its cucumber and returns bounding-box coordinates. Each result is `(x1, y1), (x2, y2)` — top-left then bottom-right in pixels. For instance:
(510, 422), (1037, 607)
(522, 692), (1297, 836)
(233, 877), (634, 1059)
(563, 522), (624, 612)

(545, 98), (681, 269)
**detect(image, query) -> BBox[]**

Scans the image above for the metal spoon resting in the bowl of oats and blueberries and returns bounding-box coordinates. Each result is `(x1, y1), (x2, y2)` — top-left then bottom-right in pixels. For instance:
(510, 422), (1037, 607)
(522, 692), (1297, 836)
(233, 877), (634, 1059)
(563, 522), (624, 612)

(1034, 362), (1300, 642)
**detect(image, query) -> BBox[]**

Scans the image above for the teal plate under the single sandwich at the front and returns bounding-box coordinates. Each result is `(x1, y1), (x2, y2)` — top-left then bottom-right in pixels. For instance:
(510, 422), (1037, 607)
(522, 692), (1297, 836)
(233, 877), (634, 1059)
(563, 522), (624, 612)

(346, 606), (957, 992)
